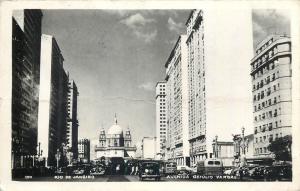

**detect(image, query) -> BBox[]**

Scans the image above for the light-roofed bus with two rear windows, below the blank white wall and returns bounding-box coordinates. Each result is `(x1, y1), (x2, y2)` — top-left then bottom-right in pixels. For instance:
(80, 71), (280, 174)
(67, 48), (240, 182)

(197, 158), (223, 176)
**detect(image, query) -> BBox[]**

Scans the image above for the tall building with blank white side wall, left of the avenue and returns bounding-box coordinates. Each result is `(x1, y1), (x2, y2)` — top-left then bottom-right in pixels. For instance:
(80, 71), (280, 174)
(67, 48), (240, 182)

(38, 34), (69, 166)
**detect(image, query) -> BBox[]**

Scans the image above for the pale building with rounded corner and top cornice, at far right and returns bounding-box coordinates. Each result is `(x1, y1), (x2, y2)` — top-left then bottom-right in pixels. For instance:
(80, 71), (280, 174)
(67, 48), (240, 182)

(251, 35), (292, 157)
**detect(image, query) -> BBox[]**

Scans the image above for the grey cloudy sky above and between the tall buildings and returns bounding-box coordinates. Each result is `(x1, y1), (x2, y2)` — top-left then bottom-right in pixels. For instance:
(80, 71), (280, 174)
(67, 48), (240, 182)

(42, 10), (290, 149)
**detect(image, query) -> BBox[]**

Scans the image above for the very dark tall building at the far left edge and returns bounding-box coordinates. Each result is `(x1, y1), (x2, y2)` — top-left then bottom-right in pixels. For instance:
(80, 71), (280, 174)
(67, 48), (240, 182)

(12, 9), (42, 168)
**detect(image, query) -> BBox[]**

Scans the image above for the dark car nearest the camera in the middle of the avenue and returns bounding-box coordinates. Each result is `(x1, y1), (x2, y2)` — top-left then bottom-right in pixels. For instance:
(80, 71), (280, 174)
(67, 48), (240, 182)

(139, 161), (161, 181)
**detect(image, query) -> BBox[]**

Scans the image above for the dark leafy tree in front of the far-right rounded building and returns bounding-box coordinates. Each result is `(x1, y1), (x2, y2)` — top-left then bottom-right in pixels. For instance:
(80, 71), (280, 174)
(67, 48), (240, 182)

(268, 135), (292, 161)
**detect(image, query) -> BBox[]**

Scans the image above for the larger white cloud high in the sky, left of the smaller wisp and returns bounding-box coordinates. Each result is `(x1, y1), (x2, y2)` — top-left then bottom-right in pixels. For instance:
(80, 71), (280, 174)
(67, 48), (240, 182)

(120, 13), (157, 43)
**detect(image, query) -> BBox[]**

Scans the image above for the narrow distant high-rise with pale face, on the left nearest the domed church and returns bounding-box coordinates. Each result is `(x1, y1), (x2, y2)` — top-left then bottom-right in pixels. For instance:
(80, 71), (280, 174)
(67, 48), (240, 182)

(67, 80), (79, 159)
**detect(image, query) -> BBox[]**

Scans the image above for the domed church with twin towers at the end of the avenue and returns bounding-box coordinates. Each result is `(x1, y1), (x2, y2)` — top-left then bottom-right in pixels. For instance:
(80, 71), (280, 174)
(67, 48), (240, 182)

(95, 116), (136, 159)
